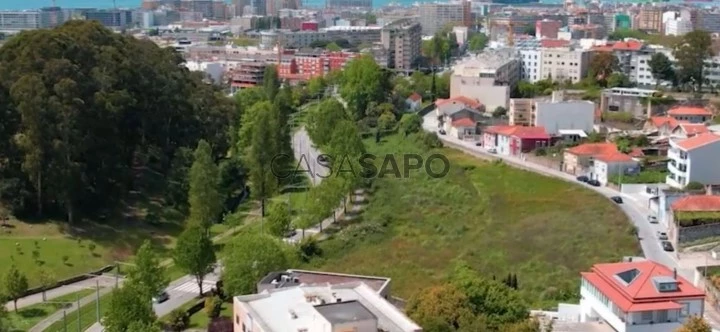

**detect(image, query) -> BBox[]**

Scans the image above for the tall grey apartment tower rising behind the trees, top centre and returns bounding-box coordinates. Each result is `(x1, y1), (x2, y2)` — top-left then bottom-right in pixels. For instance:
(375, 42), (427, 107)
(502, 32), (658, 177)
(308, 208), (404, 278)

(380, 19), (422, 72)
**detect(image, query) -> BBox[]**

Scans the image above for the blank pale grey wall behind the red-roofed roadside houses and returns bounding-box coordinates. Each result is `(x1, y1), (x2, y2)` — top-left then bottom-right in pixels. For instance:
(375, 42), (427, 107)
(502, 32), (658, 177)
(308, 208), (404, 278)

(535, 100), (595, 135)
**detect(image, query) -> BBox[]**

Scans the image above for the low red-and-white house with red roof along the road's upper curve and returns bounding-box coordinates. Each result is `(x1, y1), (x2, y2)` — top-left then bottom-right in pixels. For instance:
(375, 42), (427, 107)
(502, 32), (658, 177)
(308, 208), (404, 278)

(483, 126), (550, 156)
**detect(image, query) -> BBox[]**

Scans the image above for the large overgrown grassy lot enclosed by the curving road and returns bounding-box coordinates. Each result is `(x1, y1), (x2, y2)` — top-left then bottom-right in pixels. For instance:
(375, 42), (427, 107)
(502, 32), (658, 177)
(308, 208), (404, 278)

(300, 136), (639, 307)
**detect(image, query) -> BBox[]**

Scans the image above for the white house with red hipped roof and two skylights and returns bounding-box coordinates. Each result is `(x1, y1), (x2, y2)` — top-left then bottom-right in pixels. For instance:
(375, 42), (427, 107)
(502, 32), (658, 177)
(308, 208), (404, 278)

(580, 260), (705, 332)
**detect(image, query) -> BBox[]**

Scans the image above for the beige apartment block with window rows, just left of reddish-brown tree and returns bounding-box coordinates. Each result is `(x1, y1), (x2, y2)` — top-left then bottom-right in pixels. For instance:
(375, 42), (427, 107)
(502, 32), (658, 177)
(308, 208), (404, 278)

(540, 46), (592, 83)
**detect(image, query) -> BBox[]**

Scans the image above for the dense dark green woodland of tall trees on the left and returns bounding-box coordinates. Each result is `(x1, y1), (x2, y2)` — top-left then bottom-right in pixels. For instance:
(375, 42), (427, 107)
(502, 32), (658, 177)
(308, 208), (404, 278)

(0, 21), (237, 222)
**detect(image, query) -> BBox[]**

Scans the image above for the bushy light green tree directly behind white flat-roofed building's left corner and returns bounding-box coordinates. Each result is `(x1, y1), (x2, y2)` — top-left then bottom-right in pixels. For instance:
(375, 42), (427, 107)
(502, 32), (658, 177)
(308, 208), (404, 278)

(223, 233), (294, 294)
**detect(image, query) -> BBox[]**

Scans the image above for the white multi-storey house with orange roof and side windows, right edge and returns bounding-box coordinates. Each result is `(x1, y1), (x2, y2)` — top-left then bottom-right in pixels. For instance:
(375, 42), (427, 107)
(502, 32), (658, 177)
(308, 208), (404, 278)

(665, 133), (720, 188)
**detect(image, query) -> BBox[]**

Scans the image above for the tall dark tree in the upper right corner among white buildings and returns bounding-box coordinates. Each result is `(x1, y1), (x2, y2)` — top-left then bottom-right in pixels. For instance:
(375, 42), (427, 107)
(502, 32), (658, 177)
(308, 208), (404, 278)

(673, 30), (713, 92)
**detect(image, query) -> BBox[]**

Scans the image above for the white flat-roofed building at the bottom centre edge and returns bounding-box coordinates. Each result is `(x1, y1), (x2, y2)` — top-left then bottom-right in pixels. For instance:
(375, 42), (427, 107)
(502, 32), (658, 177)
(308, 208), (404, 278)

(233, 282), (422, 332)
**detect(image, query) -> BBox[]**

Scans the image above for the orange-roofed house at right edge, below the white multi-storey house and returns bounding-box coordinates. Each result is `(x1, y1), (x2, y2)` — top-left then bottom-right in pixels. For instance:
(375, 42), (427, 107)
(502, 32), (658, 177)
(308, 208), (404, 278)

(668, 195), (720, 246)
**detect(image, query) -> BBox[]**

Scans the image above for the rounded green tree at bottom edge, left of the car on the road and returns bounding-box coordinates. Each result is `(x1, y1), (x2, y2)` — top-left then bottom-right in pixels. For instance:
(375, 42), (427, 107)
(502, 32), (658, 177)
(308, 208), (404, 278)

(103, 284), (156, 332)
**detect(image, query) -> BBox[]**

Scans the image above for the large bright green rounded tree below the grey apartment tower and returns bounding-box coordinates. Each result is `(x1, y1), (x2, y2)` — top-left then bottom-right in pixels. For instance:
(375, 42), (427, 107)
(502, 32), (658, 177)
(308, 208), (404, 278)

(340, 55), (392, 120)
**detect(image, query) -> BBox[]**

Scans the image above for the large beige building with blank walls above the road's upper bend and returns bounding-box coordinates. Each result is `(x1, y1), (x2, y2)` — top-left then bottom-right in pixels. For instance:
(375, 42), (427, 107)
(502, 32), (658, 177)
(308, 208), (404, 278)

(450, 49), (521, 112)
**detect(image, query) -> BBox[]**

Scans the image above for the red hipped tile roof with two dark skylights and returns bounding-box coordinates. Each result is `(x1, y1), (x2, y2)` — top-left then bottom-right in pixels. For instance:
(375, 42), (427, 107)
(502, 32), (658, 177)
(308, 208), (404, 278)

(581, 261), (705, 312)
